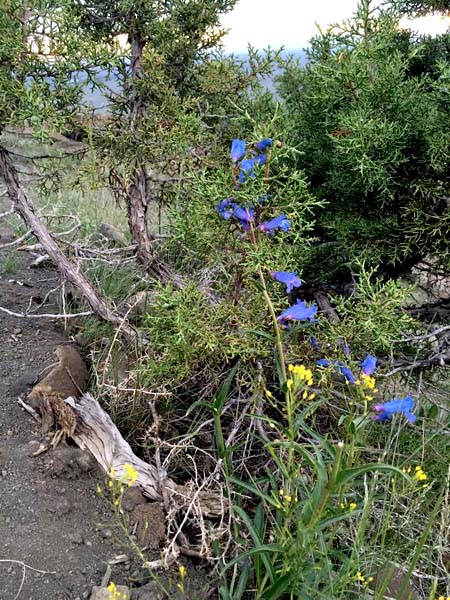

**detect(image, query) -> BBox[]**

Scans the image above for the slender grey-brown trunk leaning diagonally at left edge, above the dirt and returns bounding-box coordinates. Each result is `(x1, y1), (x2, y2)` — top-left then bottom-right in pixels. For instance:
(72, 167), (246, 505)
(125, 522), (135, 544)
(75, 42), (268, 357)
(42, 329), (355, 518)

(0, 146), (137, 341)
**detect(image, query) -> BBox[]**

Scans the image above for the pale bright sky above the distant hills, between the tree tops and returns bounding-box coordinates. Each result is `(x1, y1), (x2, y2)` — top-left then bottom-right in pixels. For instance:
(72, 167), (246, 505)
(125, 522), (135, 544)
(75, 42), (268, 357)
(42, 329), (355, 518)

(222, 0), (449, 52)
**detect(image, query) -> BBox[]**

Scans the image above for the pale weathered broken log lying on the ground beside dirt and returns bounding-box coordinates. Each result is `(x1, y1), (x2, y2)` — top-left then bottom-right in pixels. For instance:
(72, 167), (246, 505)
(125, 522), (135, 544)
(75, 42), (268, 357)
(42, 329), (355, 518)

(66, 394), (227, 516)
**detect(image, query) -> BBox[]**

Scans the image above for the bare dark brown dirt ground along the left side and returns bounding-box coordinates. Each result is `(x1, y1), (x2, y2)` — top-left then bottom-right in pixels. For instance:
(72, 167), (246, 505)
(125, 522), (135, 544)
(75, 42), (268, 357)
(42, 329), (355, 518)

(0, 198), (134, 600)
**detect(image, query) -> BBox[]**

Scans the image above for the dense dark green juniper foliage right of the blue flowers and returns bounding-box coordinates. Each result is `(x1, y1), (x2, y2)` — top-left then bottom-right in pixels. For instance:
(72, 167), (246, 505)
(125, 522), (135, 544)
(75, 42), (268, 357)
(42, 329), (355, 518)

(279, 0), (450, 279)
